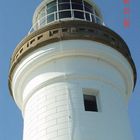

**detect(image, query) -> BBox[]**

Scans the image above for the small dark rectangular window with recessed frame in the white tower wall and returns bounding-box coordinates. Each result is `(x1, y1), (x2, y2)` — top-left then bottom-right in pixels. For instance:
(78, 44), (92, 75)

(83, 89), (99, 112)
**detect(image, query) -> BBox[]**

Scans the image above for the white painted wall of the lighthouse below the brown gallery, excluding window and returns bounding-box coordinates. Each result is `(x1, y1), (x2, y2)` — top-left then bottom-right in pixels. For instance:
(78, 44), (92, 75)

(12, 40), (134, 140)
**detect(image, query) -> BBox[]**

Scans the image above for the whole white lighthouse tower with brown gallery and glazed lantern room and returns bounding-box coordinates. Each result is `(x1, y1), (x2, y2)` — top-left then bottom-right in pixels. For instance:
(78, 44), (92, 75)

(9, 0), (136, 140)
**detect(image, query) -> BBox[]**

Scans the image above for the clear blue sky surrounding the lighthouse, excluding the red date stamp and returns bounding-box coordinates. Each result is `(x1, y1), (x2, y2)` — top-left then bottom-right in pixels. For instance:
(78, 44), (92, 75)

(0, 0), (140, 140)
